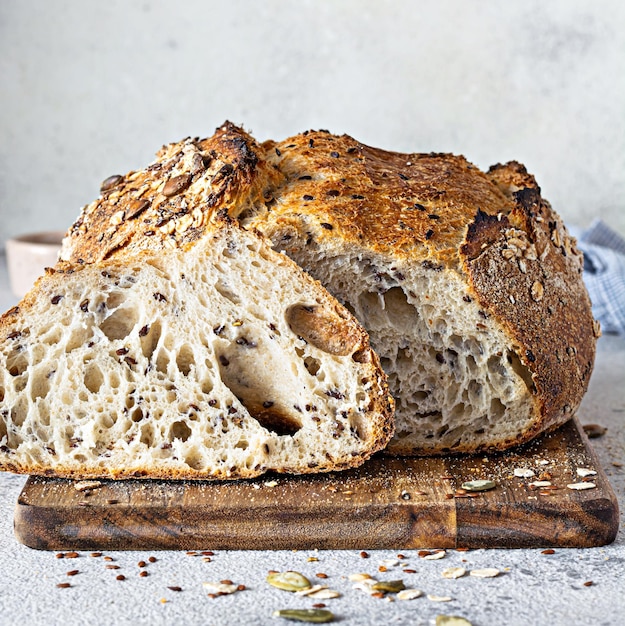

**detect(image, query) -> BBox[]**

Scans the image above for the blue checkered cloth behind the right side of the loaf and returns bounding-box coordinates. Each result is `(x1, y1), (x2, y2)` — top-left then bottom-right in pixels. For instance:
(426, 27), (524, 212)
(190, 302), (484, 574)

(570, 220), (625, 335)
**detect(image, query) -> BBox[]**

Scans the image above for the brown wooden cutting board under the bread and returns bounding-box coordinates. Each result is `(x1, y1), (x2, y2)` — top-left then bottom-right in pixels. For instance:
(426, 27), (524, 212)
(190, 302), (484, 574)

(15, 421), (618, 550)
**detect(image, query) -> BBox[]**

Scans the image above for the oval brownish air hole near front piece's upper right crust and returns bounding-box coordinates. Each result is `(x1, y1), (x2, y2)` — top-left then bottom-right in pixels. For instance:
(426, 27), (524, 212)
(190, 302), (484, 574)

(285, 303), (360, 356)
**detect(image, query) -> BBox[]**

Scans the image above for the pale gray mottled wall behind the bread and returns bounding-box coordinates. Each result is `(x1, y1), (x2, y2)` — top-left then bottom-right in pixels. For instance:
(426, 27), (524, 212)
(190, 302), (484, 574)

(0, 0), (625, 247)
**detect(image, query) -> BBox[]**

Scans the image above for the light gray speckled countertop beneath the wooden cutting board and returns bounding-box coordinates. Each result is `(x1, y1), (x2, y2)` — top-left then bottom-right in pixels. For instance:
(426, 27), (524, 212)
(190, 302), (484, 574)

(0, 257), (625, 626)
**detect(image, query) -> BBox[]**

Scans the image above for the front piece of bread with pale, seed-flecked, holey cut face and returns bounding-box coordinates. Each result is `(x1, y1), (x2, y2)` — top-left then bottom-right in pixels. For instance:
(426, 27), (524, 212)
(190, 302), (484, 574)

(0, 223), (393, 479)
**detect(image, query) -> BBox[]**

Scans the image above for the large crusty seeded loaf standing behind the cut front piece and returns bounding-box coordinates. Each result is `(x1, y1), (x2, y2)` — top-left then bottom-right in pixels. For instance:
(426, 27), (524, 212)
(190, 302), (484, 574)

(63, 123), (599, 455)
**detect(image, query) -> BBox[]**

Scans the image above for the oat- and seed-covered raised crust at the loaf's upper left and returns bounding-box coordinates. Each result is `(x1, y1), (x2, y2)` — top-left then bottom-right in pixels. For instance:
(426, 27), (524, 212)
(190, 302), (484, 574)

(62, 122), (280, 263)
